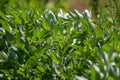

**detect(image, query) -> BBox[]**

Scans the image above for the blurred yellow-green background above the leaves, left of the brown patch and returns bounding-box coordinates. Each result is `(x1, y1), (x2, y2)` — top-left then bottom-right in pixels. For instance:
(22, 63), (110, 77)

(5, 0), (69, 12)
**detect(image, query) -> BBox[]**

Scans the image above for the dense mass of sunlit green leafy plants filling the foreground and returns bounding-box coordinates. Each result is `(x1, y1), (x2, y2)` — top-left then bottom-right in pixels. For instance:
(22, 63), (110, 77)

(0, 0), (120, 80)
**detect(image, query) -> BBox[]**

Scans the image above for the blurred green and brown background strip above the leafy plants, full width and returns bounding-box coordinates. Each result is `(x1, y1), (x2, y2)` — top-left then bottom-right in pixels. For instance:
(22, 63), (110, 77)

(0, 0), (120, 21)
